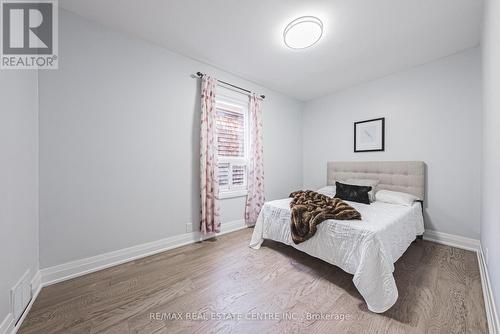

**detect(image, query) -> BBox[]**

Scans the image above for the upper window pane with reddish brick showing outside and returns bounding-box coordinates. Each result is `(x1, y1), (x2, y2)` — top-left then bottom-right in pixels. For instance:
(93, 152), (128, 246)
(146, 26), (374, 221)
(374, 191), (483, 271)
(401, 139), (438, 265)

(216, 109), (245, 157)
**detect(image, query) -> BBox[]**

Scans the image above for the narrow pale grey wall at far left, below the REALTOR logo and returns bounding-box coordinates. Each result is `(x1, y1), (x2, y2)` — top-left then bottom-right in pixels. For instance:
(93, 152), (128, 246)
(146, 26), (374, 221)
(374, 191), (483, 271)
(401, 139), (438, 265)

(0, 70), (38, 323)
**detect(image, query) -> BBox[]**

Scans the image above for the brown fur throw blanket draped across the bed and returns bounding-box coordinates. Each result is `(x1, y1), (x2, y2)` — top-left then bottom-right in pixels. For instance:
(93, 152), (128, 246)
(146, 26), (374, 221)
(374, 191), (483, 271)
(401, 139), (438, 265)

(290, 190), (361, 244)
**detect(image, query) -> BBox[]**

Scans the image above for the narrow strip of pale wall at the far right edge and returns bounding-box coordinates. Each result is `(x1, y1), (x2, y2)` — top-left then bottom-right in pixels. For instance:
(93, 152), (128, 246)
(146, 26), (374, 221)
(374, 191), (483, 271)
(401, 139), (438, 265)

(481, 0), (500, 316)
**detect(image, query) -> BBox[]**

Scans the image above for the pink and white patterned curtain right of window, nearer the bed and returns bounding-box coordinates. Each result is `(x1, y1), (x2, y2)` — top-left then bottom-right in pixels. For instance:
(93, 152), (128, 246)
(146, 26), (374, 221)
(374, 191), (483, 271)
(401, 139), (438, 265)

(245, 94), (264, 224)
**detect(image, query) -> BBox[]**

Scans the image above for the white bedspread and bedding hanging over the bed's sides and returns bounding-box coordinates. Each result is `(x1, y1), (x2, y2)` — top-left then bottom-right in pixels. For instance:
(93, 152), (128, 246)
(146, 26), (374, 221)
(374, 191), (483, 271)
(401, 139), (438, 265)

(250, 198), (424, 313)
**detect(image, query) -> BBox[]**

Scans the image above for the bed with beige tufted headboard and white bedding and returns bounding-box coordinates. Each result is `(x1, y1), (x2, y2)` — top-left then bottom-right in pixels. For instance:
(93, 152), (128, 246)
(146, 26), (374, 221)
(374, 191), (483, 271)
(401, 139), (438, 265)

(250, 161), (425, 313)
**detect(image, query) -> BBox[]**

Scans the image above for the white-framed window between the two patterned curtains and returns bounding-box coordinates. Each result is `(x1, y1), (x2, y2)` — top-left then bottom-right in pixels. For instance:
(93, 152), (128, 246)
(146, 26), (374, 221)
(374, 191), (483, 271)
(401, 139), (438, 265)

(215, 97), (248, 198)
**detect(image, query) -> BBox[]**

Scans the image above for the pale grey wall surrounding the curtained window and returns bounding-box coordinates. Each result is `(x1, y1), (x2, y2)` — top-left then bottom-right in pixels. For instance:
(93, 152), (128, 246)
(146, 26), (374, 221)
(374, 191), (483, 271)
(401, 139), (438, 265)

(40, 11), (302, 268)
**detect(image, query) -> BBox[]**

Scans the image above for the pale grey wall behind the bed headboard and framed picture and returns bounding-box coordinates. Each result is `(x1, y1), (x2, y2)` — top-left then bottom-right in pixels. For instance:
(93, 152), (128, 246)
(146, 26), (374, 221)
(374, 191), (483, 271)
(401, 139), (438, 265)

(302, 48), (481, 239)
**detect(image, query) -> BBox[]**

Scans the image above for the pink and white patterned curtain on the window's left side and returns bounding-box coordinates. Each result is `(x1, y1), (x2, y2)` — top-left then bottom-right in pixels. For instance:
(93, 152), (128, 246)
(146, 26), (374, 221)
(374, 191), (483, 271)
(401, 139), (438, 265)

(200, 76), (220, 234)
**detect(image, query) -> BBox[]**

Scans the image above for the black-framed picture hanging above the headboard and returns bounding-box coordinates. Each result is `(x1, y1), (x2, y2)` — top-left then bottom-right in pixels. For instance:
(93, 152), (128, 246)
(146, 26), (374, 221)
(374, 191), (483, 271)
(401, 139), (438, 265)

(354, 117), (385, 152)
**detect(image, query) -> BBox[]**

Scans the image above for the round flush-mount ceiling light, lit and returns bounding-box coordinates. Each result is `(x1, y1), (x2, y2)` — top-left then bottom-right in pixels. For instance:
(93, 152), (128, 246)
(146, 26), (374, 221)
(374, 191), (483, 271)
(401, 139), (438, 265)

(283, 16), (323, 49)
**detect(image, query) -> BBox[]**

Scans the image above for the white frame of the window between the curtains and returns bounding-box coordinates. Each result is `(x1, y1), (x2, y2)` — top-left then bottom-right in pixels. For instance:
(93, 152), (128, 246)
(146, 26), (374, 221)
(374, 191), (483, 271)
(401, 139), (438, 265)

(215, 95), (250, 199)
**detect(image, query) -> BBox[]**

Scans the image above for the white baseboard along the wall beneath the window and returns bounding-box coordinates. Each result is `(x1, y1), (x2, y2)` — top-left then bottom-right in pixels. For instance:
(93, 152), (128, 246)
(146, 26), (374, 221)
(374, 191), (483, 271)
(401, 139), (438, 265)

(41, 220), (247, 286)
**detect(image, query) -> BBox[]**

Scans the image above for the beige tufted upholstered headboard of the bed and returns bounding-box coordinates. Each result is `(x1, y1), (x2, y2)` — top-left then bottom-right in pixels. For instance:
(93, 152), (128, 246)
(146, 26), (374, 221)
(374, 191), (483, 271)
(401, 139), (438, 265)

(327, 161), (425, 200)
